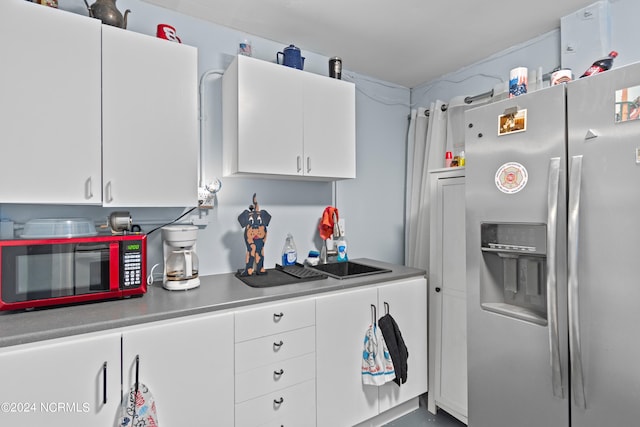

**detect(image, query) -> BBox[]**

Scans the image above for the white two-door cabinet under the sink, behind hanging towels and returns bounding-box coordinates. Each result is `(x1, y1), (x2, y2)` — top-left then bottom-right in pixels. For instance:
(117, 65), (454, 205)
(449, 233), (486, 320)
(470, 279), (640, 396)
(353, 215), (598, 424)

(316, 278), (428, 427)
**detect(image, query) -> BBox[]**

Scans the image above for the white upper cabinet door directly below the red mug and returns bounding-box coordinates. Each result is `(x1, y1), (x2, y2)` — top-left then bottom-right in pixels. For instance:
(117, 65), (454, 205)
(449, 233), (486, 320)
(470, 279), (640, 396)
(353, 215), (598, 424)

(102, 25), (198, 207)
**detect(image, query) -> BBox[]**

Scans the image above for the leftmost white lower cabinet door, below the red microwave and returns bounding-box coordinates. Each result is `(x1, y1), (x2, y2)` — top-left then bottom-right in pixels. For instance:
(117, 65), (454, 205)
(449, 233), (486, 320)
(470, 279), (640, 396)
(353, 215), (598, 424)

(0, 333), (120, 427)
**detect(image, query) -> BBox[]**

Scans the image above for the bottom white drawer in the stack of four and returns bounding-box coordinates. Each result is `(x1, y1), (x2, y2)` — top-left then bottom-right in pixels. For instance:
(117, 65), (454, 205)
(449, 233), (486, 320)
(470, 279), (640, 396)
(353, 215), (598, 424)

(235, 380), (316, 427)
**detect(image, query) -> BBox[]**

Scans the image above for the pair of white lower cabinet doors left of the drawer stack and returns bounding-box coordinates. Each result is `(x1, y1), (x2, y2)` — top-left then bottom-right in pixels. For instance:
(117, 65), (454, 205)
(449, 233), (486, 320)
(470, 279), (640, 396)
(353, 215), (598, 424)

(0, 313), (234, 427)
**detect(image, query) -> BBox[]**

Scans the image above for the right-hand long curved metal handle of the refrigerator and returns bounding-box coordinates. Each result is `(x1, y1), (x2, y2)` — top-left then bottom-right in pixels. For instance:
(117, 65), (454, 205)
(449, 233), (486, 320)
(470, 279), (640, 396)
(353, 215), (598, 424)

(567, 156), (587, 409)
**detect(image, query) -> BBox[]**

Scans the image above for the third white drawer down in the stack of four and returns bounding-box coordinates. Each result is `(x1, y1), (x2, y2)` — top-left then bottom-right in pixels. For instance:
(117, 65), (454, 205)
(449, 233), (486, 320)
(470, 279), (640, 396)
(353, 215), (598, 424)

(235, 353), (316, 403)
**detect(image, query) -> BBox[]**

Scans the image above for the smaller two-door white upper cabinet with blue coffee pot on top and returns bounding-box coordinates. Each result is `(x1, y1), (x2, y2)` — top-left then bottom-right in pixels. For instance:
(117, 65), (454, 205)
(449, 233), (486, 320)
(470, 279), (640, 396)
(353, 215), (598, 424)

(222, 56), (356, 180)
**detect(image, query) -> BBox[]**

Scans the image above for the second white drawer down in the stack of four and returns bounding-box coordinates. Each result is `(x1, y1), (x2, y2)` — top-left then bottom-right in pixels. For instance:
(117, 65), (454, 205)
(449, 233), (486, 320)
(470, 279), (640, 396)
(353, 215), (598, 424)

(236, 326), (316, 373)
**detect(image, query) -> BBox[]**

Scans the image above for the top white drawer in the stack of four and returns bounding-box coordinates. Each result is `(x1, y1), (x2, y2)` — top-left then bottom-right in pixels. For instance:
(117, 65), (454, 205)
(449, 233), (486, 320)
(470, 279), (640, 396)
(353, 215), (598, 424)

(235, 299), (316, 342)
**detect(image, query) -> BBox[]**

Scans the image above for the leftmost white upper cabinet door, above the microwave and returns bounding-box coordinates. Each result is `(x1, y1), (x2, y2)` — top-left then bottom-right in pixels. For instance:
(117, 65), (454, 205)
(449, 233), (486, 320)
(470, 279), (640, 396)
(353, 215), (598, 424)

(0, 1), (101, 204)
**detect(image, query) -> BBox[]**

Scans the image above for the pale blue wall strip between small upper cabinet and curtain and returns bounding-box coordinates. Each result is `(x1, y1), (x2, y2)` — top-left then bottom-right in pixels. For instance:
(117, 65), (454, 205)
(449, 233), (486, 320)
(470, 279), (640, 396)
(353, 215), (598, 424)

(336, 76), (409, 264)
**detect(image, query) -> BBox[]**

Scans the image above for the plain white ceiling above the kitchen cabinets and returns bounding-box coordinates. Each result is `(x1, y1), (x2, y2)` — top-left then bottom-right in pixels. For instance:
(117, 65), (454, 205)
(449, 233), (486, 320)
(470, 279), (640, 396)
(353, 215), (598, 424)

(145, 0), (595, 88)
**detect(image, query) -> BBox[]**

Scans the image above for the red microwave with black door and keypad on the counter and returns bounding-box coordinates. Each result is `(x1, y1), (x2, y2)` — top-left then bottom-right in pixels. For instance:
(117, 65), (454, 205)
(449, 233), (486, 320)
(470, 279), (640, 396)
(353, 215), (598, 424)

(0, 234), (147, 310)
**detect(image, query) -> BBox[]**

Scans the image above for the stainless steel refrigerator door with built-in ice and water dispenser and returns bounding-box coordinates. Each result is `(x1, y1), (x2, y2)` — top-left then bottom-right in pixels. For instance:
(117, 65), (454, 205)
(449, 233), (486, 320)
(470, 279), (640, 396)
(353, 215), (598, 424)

(465, 86), (569, 427)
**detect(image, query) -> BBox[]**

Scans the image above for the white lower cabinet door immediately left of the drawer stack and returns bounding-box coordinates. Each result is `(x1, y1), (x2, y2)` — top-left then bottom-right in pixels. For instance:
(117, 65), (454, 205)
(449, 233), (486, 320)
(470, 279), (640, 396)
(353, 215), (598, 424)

(122, 313), (234, 426)
